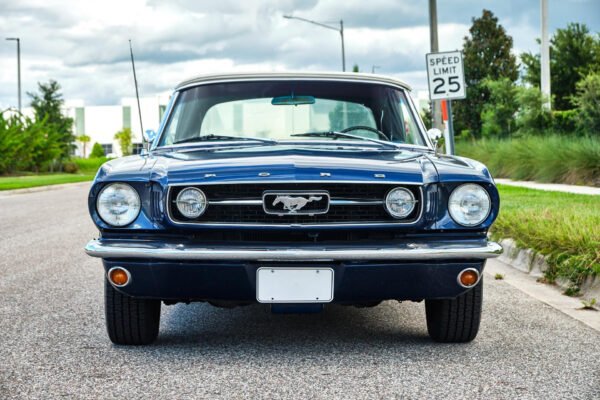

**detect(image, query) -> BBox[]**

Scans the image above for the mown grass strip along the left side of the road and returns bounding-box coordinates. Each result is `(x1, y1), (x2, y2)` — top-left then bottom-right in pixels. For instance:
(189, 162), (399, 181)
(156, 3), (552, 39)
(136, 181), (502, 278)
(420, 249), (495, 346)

(0, 158), (107, 190)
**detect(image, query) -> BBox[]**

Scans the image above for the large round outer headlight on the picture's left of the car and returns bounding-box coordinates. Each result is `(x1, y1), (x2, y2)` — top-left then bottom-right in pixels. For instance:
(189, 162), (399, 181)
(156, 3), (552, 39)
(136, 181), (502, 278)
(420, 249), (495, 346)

(96, 183), (141, 226)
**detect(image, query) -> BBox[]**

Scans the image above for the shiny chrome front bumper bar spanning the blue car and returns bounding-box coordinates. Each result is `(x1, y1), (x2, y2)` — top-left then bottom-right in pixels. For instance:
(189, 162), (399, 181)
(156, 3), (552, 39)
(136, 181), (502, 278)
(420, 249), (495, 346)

(85, 240), (502, 261)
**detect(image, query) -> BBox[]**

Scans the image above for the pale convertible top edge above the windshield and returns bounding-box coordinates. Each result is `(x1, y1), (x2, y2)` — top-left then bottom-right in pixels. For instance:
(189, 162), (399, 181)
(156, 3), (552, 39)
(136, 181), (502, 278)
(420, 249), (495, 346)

(175, 72), (411, 90)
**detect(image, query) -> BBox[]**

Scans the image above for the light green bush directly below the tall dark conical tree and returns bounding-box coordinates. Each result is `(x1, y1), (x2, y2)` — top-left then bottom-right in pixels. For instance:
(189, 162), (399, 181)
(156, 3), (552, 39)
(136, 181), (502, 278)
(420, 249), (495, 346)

(481, 78), (518, 137)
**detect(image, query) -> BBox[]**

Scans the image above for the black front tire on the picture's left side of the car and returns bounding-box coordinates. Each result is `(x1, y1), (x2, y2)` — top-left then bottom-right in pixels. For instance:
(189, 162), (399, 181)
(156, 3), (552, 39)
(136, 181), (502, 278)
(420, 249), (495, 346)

(104, 280), (160, 345)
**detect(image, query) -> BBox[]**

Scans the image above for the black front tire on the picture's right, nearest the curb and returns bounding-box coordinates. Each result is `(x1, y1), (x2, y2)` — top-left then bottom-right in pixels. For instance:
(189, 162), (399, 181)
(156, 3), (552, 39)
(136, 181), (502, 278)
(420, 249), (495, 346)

(425, 280), (483, 343)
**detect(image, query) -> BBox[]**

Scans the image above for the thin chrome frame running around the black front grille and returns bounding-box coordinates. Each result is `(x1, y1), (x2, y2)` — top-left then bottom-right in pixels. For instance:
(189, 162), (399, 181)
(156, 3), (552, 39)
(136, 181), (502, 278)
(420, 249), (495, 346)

(164, 186), (425, 228)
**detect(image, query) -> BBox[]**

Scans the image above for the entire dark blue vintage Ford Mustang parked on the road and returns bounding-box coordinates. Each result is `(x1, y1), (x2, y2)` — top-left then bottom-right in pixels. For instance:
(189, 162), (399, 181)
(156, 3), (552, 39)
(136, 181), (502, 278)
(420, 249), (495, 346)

(86, 73), (502, 344)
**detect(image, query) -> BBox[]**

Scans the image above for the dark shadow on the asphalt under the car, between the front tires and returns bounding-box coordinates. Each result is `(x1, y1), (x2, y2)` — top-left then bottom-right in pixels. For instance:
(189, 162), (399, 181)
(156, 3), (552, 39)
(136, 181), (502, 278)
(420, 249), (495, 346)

(142, 301), (432, 357)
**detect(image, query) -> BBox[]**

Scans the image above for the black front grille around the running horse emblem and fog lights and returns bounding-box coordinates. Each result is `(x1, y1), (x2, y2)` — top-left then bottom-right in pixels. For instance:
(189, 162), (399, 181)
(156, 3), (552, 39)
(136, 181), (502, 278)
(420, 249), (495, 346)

(168, 182), (423, 225)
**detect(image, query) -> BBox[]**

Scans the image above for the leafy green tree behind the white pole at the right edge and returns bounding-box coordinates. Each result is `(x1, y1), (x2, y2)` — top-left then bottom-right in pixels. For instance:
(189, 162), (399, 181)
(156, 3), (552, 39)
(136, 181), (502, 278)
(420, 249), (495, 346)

(521, 23), (600, 110)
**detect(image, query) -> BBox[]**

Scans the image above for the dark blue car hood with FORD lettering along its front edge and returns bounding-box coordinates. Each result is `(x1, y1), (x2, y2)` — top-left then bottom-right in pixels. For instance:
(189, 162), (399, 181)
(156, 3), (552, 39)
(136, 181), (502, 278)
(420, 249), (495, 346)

(97, 146), (491, 185)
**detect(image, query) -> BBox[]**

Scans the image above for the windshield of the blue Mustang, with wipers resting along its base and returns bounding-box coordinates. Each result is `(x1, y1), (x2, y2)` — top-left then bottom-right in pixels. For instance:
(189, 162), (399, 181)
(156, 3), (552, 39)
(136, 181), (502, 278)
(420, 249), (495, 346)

(159, 80), (426, 146)
